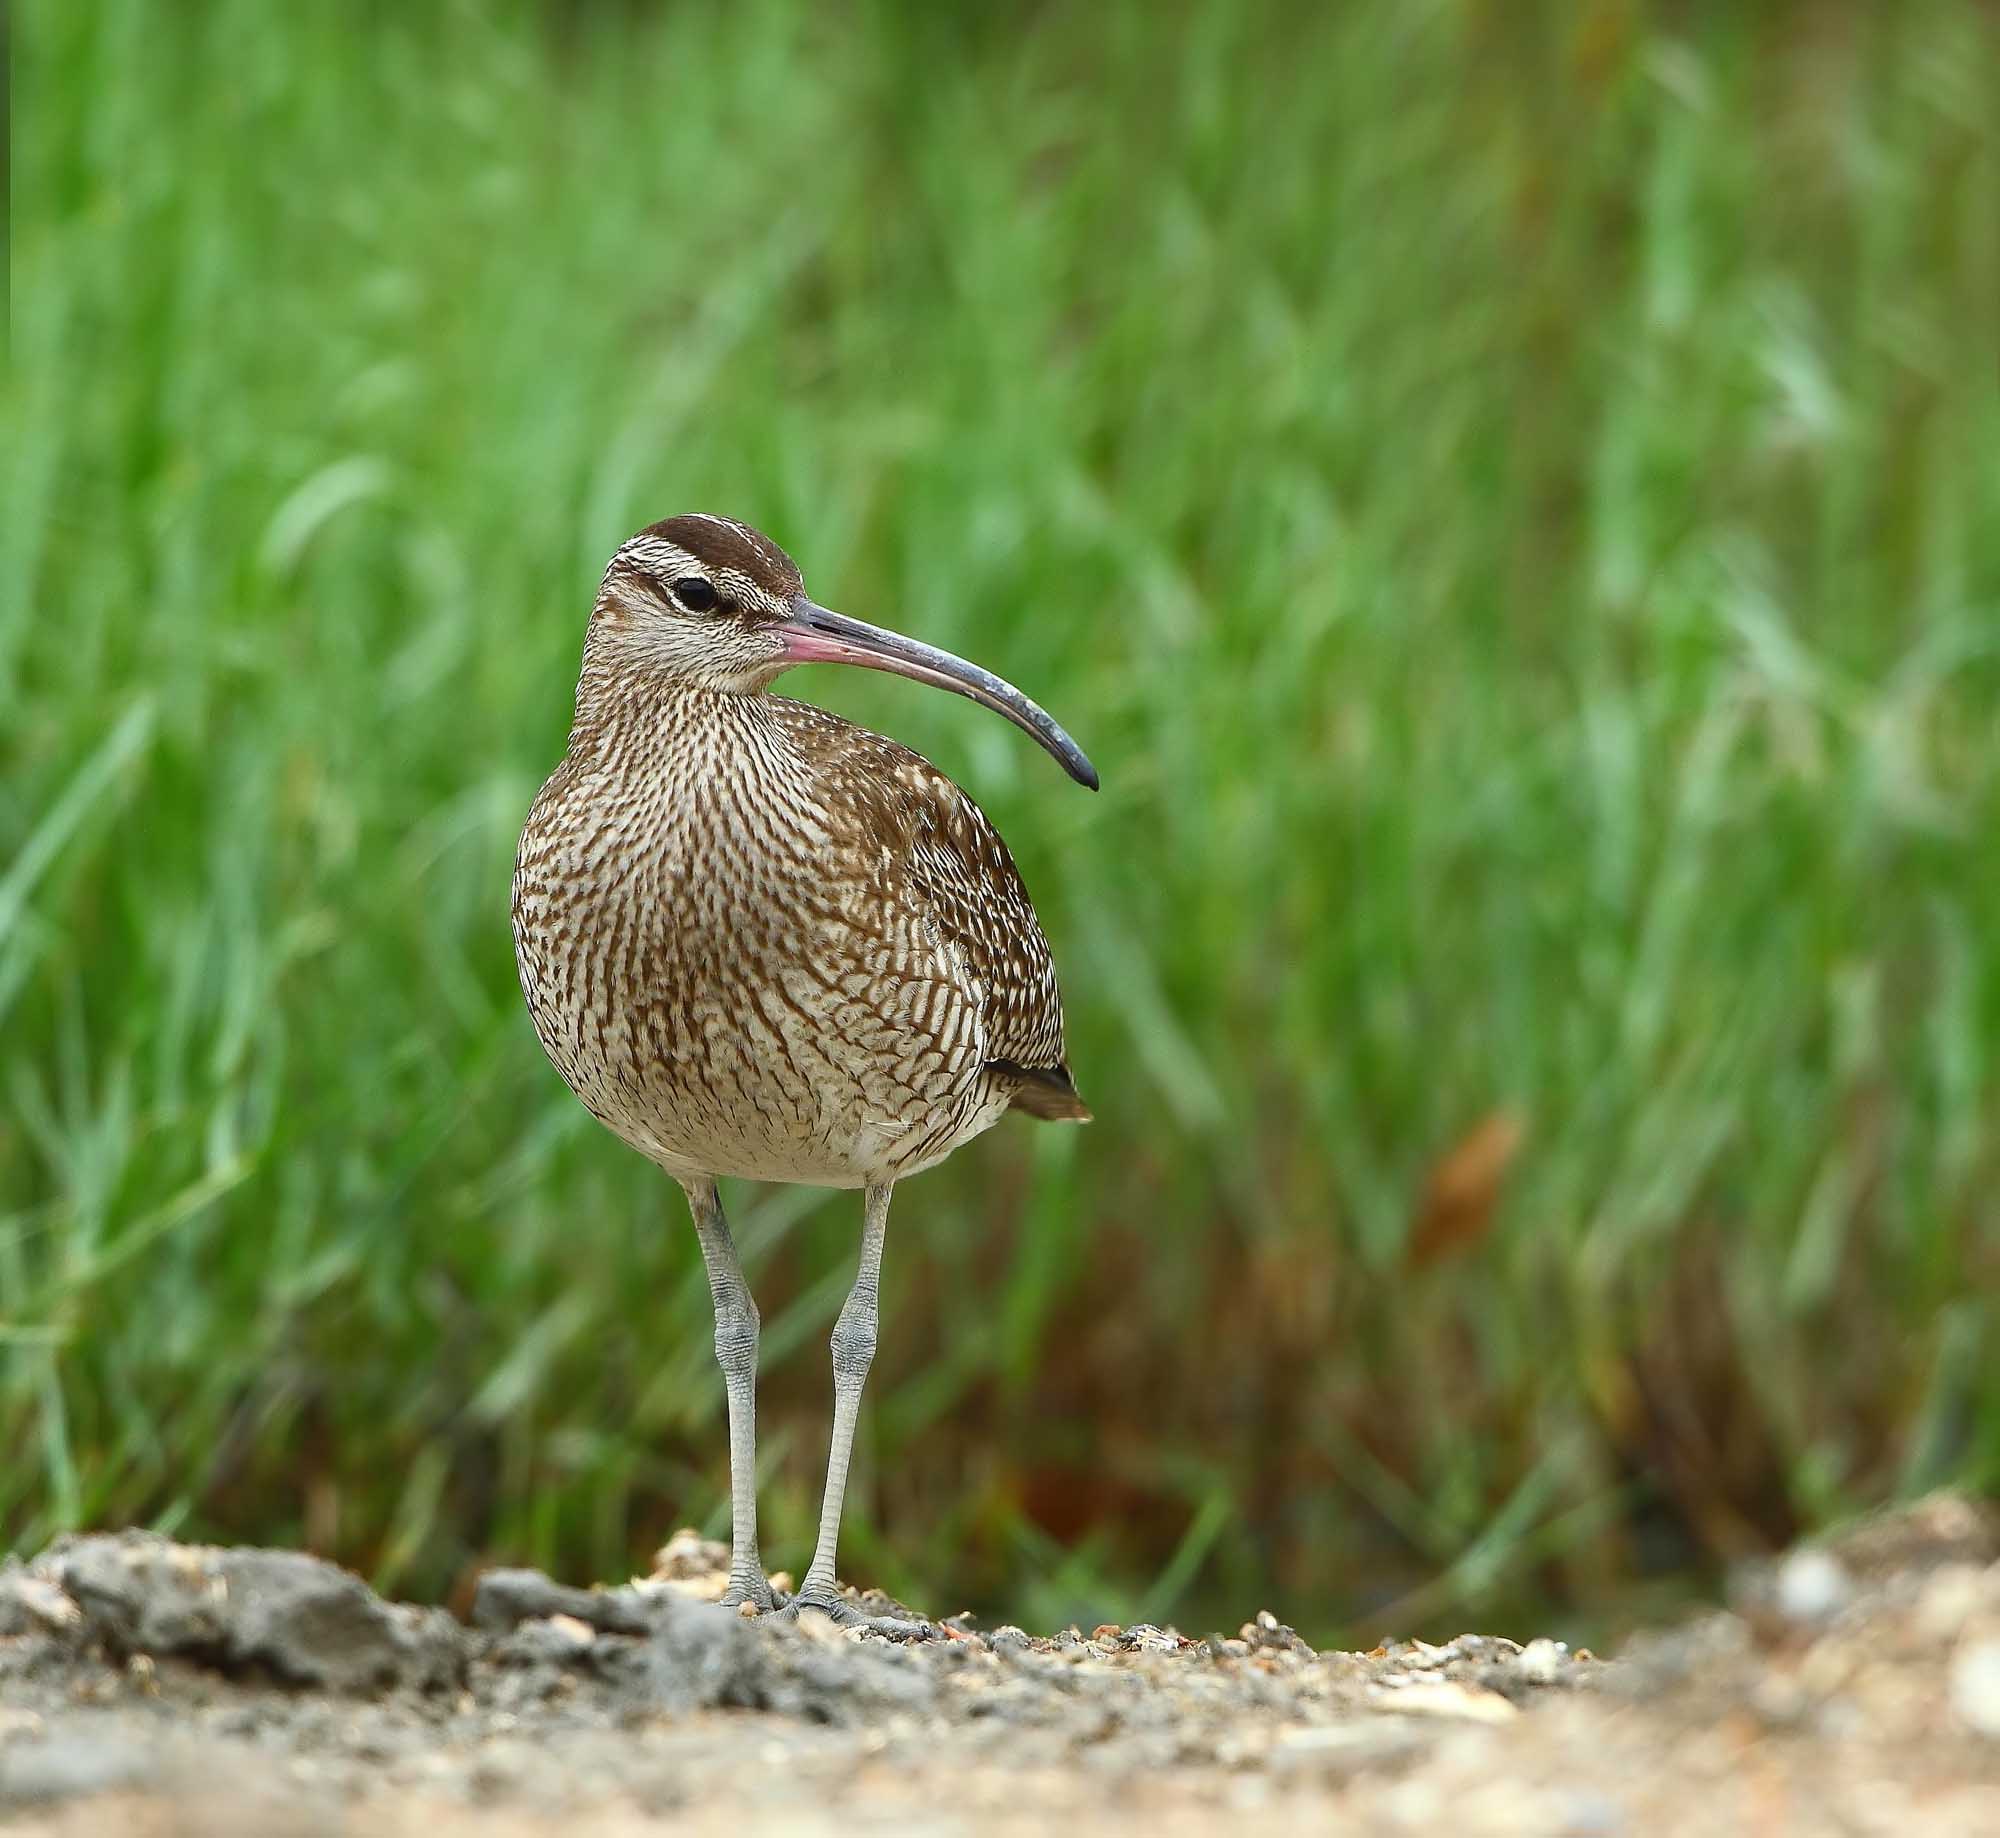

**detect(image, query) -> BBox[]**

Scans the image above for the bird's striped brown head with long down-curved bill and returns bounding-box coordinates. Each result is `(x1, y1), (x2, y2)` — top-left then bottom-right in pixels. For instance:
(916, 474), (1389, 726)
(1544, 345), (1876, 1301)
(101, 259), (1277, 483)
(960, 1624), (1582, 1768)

(586, 516), (1098, 790)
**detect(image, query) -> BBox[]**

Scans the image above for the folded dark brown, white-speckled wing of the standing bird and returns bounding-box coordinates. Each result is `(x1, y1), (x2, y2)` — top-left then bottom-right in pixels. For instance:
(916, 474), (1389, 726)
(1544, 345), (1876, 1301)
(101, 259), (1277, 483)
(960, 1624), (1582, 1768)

(772, 696), (1090, 1120)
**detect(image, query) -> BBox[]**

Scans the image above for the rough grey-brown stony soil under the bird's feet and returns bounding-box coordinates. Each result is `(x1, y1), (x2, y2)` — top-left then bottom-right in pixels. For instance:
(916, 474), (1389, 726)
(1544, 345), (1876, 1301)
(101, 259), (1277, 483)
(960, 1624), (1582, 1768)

(0, 1498), (2000, 1838)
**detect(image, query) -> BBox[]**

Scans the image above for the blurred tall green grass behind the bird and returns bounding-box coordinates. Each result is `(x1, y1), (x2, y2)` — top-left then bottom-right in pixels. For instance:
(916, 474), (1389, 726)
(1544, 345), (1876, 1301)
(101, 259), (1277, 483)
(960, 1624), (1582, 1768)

(0, 0), (2000, 1636)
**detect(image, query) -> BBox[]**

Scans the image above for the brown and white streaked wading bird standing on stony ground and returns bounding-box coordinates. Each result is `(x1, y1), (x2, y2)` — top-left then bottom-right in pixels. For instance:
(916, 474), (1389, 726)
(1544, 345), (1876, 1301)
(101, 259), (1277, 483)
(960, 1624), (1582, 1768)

(514, 516), (1098, 1634)
